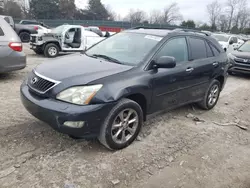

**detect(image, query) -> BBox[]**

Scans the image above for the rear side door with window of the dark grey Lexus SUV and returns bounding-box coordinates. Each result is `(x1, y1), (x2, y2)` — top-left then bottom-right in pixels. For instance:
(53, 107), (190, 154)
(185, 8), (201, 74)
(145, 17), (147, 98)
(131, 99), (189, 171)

(188, 36), (219, 101)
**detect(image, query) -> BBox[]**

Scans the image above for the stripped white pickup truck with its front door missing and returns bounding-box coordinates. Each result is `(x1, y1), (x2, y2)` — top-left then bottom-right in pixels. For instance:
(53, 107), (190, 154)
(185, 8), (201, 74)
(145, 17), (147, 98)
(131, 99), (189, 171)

(30, 25), (104, 57)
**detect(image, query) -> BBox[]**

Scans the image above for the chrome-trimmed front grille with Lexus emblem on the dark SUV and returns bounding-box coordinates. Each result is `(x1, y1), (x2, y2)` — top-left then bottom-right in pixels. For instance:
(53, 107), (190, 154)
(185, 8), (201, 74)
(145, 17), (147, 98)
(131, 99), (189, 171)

(28, 72), (59, 94)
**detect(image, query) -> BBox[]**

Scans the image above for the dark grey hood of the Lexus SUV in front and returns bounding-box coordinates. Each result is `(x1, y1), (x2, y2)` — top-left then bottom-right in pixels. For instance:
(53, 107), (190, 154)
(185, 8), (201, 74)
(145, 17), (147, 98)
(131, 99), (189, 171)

(35, 54), (133, 84)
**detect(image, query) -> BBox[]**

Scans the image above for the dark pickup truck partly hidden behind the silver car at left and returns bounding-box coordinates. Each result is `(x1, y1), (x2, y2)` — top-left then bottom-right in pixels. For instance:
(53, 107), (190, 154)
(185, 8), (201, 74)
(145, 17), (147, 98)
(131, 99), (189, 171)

(0, 15), (38, 42)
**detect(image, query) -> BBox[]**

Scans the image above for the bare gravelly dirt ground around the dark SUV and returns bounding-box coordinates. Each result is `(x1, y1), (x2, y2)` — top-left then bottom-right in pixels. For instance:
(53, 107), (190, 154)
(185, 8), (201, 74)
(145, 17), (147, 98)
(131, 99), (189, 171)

(0, 45), (250, 188)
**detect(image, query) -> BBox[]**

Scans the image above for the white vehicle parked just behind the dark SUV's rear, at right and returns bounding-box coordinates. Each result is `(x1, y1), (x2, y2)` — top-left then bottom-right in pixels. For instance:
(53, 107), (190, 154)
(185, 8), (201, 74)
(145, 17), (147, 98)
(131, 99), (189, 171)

(212, 33), (244, 51)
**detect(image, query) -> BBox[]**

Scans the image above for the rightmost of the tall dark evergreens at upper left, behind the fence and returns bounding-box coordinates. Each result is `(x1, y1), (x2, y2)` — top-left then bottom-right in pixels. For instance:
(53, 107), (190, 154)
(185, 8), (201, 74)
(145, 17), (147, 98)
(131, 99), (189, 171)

(88, 0), (109, 20)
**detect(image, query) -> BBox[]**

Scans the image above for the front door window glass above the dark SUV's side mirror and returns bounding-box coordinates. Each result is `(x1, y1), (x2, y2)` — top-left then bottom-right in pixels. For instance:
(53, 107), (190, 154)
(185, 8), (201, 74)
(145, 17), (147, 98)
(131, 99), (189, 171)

(157, 38), (188, 63)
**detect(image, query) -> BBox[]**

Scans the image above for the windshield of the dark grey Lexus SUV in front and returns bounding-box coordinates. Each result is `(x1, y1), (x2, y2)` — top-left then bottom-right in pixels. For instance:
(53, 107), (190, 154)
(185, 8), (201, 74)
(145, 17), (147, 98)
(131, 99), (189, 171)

(86, 32), (162, 66)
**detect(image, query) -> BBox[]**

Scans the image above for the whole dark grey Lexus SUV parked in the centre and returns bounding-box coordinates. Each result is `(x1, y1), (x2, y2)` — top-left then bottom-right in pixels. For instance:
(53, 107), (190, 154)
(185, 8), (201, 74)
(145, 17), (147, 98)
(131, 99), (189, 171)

(21, 28), (228, 149)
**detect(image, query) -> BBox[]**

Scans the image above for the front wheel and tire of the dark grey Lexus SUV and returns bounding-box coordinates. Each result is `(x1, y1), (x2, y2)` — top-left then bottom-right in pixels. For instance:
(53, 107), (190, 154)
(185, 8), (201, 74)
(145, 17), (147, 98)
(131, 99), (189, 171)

(98, 99), (143, 150)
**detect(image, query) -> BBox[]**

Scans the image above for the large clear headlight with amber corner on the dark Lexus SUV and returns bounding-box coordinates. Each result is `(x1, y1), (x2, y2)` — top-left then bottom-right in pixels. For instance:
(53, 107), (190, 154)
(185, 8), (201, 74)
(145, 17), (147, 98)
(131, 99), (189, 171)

(56, 84), (102, 105)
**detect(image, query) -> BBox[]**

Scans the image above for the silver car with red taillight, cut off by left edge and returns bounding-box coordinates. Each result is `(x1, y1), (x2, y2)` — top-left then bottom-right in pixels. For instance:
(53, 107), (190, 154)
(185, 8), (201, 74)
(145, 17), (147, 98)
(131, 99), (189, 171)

(0, 17), (26, 73)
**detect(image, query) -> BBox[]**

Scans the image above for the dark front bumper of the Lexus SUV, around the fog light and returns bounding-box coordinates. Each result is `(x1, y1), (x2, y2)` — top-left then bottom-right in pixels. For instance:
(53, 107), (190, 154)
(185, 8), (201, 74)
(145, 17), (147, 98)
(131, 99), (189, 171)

(21, 84), (116, 138)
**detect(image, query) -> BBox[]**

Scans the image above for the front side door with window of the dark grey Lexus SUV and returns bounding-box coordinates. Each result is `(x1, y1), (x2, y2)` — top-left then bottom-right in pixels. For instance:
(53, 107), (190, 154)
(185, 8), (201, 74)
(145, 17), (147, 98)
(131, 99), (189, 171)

(151, 37), (195, 113)
